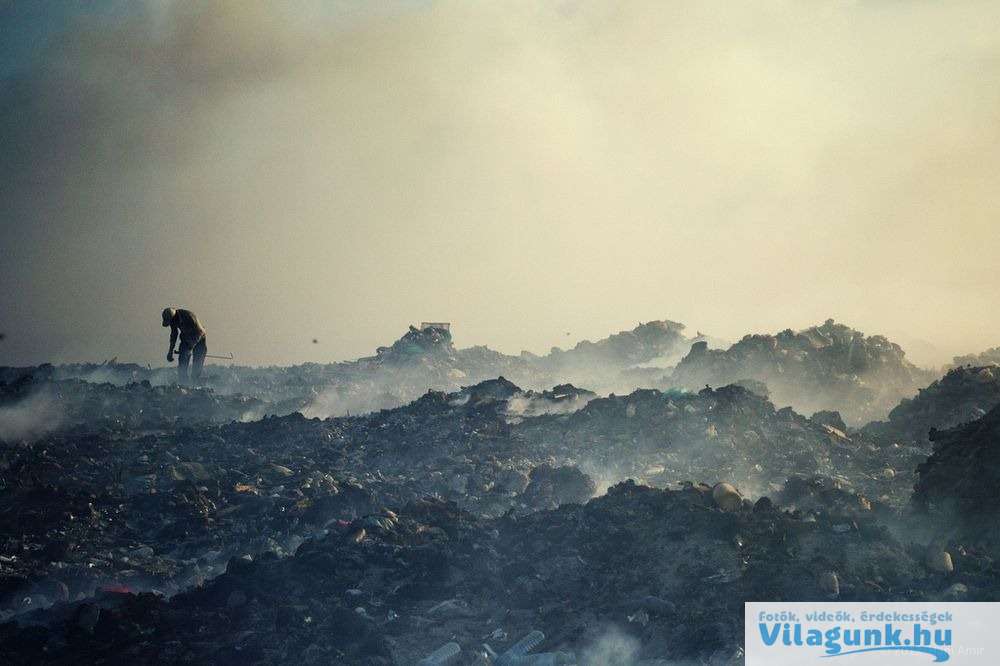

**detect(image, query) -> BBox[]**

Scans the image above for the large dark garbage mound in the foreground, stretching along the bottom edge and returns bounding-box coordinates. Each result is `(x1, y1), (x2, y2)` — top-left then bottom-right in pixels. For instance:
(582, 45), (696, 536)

(0, 482), (998, 665)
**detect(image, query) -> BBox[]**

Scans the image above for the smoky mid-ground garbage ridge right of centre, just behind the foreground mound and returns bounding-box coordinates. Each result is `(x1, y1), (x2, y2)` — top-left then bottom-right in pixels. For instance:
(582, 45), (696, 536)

(514, 386), (926, 506)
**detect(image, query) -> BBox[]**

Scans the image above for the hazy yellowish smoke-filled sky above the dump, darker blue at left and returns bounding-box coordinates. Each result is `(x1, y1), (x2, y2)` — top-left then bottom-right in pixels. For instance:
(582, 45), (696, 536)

(0, 0), (1000, 364)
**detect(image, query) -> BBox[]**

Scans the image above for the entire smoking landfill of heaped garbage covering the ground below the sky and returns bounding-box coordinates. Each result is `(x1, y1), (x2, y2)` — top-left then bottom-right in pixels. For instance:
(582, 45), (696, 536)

(0, 322), (1000, 666)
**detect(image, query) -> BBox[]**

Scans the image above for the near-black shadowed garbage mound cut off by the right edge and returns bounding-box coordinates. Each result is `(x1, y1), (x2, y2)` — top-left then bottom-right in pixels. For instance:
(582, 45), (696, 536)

(913, 406), (1000, 555)
